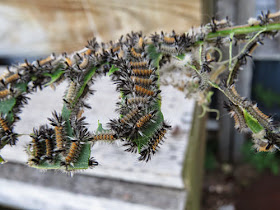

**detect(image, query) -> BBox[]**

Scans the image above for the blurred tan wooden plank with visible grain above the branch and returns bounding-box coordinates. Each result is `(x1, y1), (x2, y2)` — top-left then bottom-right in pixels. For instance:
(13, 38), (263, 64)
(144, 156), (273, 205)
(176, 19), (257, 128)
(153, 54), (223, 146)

(0, 0), (201, 55)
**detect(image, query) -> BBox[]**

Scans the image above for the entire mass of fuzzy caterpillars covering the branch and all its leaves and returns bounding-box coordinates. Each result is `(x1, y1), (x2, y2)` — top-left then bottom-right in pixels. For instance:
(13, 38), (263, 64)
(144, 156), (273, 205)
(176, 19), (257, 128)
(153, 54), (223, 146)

(0, 12), (280, 169)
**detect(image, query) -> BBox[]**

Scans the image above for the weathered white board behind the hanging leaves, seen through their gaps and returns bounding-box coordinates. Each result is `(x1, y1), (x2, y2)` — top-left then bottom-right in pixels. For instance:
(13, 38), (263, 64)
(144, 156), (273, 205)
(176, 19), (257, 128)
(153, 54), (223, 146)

(1, 78), (194, 189)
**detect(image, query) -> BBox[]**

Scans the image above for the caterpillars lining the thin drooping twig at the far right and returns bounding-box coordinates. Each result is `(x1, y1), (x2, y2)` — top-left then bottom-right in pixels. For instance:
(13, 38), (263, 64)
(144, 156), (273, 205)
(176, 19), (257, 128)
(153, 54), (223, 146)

(221, 12), (280, 152)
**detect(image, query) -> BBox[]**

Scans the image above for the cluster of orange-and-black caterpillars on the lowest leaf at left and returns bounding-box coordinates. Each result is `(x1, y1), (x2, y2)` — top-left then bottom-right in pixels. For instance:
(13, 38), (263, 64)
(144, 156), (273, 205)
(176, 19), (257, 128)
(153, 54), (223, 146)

(27, 112), (98, 171)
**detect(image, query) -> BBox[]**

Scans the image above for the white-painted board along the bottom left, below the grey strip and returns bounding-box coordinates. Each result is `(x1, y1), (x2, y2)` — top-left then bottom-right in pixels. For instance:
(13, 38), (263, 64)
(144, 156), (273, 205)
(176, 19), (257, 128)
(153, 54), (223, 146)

(0, 179), (158, 210)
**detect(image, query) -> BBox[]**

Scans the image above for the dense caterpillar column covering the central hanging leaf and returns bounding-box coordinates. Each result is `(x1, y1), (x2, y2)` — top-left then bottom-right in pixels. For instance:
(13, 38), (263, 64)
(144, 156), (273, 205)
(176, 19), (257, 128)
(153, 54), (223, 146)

(106, 33), (175, 161)
